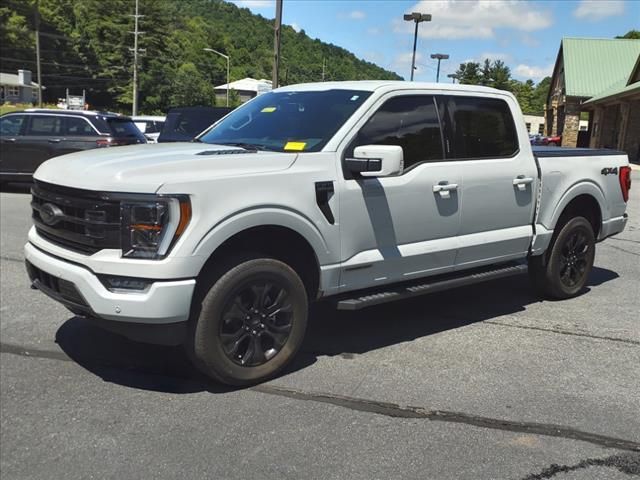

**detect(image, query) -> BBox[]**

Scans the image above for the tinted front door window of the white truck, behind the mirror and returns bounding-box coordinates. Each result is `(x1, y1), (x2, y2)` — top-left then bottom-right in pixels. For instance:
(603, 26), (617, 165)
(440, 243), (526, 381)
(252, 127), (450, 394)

(347, 95), (443, 169)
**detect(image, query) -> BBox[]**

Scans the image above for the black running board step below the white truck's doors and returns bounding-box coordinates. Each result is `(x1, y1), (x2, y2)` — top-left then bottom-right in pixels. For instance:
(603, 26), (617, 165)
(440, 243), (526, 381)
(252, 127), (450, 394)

(337, 262), (527, 310)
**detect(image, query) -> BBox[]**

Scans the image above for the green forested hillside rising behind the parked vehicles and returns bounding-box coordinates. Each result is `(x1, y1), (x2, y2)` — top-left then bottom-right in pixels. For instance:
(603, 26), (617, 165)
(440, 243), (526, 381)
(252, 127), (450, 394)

(0, 0), (400, 113)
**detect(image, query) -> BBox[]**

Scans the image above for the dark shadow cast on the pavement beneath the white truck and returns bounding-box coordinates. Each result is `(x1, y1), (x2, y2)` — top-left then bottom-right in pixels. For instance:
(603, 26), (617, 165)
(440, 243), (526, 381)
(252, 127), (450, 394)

(56, 267), (618, 394)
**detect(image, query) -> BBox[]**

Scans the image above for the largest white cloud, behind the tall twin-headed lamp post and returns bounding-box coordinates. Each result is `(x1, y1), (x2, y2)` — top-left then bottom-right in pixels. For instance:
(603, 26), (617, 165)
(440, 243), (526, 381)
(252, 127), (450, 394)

(394, 0), (552, 40)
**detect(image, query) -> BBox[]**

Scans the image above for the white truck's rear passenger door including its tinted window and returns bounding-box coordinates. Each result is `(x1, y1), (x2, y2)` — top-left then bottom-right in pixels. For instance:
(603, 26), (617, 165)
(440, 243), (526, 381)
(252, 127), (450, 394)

(441, 94), (538, 269)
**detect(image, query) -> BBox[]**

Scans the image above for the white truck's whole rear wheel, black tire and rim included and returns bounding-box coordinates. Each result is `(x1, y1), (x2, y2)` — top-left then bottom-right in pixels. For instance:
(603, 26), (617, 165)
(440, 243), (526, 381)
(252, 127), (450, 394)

(529, 217), (595, 299)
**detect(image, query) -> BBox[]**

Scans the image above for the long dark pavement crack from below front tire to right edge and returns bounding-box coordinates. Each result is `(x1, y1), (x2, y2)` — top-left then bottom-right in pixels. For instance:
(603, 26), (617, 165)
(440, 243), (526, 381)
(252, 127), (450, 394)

(251, 384), (640, 452)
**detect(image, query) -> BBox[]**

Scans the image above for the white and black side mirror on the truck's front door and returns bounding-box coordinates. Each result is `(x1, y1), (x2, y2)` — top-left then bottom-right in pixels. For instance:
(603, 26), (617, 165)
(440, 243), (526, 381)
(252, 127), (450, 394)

(345, 145), (404, 177)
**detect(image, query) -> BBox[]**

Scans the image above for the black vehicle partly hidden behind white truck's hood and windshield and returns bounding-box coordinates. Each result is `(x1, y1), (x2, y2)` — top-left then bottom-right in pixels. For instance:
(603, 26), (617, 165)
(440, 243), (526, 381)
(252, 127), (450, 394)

(158, 107), (233, 142)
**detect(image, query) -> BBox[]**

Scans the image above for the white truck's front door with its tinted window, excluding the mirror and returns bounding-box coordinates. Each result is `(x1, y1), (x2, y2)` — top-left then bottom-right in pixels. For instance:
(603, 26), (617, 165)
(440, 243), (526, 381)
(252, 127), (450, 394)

(339, 92), (462, 290)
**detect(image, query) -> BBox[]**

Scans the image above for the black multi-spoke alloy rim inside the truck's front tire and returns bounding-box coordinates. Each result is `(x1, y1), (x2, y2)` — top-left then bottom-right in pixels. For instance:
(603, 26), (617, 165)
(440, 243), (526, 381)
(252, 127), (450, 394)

(220, 279), (293, 367)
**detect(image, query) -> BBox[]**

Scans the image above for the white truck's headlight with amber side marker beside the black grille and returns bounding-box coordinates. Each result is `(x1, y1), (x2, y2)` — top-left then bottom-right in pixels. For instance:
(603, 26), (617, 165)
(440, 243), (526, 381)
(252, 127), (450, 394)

(120, 196), (191, 259)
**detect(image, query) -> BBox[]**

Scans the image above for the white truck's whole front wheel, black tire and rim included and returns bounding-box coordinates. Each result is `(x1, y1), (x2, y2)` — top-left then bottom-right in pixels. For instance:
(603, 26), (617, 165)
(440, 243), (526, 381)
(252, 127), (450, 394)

(187, 256), (309, 386)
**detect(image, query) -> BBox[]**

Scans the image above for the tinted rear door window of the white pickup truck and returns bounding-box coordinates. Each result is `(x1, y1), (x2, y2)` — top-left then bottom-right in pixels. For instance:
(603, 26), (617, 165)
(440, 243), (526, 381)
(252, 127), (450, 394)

(447, 96), (519, 158)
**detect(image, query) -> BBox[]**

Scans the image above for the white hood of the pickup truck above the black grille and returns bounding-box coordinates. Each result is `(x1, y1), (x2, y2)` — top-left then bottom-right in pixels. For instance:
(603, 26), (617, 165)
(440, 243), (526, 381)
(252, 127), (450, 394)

(34, 143), (297, 193)
